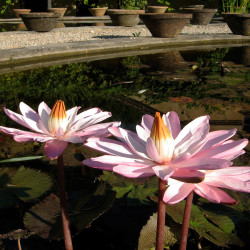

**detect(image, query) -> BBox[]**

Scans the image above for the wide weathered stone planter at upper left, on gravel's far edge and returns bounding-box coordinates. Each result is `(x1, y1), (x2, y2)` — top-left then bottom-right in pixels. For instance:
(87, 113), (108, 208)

(20, 12), (59, 32)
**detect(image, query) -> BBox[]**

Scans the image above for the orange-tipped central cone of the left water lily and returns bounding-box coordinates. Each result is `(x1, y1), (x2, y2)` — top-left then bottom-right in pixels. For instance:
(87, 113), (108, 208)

(48, 100), (68, 134)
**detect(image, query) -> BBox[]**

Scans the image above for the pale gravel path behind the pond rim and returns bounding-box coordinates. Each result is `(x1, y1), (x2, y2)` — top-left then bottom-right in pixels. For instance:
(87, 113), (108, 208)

(0, 23), (232, 50)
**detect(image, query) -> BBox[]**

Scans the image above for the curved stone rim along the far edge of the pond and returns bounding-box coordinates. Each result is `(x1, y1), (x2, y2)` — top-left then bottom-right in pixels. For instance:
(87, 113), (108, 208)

(0, 34), (250, 74)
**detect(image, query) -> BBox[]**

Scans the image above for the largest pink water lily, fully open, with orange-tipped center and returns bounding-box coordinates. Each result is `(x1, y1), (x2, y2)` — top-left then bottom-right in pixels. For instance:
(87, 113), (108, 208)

(83, 111), (248, 183)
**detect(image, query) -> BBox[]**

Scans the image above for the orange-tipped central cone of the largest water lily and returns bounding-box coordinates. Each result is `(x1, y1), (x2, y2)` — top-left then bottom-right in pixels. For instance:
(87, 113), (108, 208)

(150, 112), (174, 163)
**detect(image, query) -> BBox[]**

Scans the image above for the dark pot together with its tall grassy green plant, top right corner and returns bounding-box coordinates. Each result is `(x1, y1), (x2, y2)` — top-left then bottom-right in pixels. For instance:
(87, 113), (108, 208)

(221, 0), (250, 36)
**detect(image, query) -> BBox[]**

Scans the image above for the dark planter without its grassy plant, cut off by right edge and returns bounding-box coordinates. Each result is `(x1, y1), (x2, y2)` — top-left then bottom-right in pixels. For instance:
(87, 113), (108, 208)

(222, 13), (250, 36)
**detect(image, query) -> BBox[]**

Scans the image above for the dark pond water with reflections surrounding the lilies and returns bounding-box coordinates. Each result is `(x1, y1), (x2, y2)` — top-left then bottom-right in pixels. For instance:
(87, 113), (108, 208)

(0, 46), (250, 250)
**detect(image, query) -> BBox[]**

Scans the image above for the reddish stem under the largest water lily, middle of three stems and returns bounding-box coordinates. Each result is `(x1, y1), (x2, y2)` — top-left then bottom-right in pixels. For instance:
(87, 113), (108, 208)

(156, 178), (166, 250)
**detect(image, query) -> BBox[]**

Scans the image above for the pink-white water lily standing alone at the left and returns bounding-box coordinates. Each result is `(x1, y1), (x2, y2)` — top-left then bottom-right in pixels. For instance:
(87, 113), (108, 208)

(0, 100), (120, 159)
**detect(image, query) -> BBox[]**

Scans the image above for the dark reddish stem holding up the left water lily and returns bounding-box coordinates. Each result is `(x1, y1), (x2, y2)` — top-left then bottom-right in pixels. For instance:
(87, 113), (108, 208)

(57, 155), (73, 250)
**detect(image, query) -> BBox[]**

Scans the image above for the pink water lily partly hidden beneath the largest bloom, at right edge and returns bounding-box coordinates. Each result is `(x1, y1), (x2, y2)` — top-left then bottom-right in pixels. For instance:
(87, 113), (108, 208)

(163, 167), (250, 204)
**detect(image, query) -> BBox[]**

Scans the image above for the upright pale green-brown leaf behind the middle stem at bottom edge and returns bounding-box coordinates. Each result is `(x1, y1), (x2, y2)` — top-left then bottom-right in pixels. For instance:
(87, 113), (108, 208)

(138, 213), (180, 250)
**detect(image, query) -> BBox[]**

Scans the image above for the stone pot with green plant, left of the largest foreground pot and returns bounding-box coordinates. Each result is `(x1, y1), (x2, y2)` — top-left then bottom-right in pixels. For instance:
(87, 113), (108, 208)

(107, 0), (147, 27)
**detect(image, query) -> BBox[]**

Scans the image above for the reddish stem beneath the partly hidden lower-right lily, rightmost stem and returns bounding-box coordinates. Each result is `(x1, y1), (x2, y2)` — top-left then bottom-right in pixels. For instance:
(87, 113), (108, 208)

(179, 191), (194, 250)
